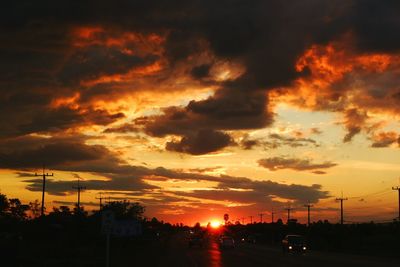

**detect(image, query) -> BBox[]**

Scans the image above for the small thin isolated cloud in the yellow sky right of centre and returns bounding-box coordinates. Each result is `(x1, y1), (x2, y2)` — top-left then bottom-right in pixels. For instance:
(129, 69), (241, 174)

(258, 157), (337, 171)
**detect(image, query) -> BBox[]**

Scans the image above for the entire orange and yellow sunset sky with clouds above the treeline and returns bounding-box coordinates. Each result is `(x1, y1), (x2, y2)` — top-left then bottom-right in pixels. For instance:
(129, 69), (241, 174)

(0, 0), (400, 224)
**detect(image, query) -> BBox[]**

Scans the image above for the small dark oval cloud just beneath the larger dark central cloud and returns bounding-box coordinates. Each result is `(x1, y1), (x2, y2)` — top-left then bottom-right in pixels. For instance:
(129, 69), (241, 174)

(165, 129), (233, 155)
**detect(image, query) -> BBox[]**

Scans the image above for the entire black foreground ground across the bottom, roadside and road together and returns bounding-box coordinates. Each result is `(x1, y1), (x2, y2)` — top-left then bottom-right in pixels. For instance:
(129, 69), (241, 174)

(7, 232), (400, 267)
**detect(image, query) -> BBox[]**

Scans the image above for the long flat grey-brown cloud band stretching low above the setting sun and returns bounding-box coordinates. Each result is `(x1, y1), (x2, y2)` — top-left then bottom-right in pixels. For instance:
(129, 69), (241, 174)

(4, 137), (327, 206)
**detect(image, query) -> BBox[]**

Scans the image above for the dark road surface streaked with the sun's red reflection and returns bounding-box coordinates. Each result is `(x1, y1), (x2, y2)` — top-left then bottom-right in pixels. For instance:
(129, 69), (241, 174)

(154, 234), (400, 267)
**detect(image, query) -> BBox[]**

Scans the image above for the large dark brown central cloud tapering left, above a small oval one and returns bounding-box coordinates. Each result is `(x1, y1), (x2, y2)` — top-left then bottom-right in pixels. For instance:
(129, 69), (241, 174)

(135, 90), (272, 137)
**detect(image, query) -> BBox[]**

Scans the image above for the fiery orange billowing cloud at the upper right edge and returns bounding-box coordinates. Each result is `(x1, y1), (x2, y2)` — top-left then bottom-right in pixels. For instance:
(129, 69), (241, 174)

(270, 38), (400, 141)
